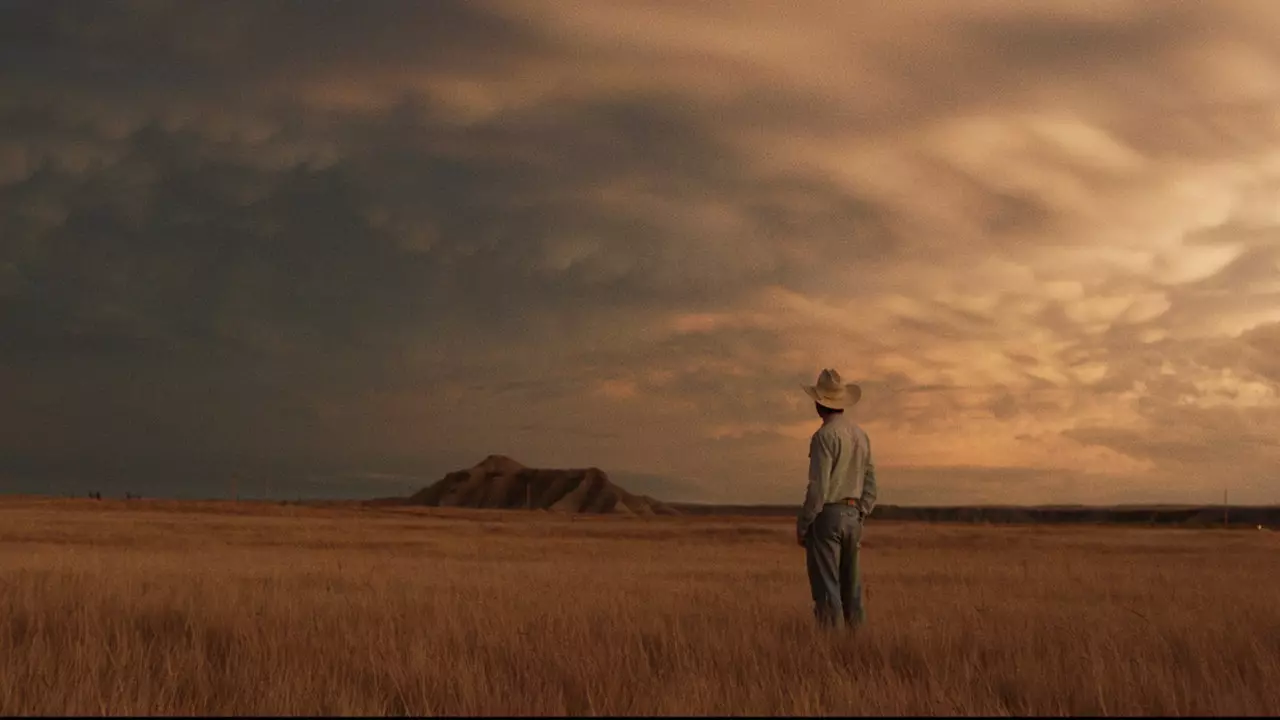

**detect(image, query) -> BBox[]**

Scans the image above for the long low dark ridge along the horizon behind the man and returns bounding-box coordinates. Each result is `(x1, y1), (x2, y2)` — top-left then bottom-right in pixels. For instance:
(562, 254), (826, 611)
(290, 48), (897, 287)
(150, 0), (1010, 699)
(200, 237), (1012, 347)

(672, 503), (1280, 528)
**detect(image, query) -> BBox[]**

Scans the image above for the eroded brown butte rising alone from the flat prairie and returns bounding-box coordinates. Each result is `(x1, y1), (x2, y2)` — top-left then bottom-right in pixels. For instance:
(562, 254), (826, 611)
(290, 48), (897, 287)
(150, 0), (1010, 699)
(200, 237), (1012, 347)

(399, 455), (678, 515)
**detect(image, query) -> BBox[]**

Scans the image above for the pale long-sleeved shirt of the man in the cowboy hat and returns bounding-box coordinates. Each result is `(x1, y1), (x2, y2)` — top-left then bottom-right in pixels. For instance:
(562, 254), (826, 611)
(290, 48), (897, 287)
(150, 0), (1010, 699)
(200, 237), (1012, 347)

(796, 413), (876, 536)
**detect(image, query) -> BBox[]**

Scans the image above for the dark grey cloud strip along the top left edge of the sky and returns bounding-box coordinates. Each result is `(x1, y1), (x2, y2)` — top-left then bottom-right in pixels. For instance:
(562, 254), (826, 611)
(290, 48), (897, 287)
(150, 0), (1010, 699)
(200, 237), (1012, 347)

(0, 0), (545, 102)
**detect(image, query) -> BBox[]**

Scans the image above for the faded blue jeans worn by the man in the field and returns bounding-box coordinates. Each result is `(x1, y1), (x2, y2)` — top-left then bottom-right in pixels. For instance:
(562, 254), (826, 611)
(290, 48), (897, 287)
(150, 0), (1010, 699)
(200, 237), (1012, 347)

(805, 505), (867, 625)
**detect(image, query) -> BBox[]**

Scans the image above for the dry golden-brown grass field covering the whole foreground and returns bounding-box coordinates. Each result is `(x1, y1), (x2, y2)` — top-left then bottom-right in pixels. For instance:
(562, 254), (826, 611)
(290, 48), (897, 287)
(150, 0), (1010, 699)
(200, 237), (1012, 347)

(0, 500), (1280, 715)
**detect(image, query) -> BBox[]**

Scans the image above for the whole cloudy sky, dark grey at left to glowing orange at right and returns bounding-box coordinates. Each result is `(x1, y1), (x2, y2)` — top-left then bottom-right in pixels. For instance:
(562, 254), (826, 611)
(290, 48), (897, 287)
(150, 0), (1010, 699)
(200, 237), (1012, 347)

(0, 0), (1280, 503)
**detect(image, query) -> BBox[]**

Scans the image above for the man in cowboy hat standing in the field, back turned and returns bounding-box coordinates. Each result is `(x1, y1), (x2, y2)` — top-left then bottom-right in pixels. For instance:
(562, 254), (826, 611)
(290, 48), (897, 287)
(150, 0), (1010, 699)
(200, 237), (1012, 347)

(796, 369), (876, 625)
